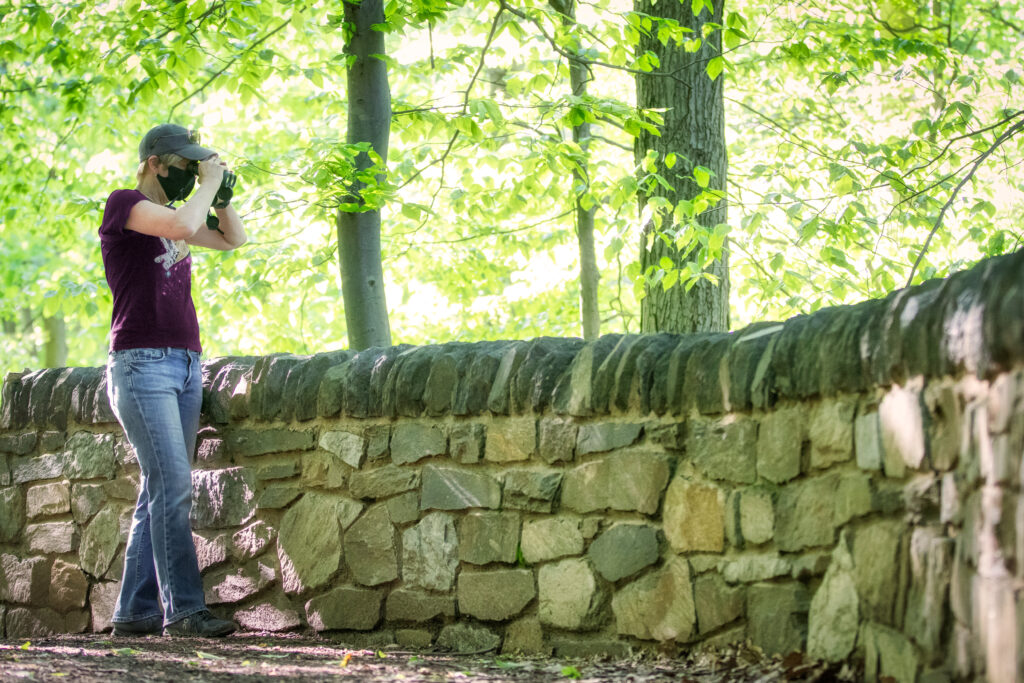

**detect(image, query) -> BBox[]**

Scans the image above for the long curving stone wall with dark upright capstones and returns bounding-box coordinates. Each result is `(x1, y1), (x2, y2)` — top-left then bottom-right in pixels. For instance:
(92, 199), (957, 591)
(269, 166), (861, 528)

(0, 254), (1024, 681)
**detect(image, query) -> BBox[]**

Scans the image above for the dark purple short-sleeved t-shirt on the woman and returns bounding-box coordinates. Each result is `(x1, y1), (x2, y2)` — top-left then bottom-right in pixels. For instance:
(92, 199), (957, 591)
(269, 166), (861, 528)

(99, 189), (203, 352)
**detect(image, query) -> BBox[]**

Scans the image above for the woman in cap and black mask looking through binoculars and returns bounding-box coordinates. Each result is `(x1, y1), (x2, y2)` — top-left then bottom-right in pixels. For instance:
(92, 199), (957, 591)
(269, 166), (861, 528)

(99, 124), (246, 637)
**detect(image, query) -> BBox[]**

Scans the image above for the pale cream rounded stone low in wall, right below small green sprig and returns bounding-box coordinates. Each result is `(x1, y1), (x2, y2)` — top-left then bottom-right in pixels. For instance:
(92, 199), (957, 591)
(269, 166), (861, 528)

(537, 559), (606, 630)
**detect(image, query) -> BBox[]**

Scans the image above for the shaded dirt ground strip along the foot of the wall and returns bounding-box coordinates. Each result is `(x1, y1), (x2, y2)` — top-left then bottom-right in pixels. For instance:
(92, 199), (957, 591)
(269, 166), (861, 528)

(0, 633), (856, 683)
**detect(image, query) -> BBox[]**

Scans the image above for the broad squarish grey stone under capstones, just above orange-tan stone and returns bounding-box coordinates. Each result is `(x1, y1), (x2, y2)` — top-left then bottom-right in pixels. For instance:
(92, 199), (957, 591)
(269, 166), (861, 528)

(686, 415), (758, 483)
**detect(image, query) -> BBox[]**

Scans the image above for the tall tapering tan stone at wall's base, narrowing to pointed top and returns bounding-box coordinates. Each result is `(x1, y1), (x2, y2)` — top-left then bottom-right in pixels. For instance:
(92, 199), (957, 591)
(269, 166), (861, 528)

(807, 539), (860, 661)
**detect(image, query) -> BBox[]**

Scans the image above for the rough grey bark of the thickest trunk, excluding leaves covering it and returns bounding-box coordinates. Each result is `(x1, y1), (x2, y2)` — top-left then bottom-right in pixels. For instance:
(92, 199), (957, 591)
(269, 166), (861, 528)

(634, 0), (729, 333)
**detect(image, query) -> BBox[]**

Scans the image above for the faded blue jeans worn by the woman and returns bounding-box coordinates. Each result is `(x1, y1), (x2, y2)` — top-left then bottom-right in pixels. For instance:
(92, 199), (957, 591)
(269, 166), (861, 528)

(106, 348), (206, 625)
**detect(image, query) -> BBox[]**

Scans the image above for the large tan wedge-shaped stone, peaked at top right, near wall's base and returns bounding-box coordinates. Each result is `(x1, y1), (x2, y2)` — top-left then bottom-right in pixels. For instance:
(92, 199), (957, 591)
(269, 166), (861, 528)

(611, 556), (696, 642)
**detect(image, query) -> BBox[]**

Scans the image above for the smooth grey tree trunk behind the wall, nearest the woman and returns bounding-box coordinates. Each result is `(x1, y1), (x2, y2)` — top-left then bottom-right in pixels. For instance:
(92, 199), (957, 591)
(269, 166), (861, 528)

(337, 0), (391, 350)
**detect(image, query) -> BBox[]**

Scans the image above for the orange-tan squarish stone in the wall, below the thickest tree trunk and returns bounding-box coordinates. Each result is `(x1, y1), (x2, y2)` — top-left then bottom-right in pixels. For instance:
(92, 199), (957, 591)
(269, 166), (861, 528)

(663, 477), (725, 553)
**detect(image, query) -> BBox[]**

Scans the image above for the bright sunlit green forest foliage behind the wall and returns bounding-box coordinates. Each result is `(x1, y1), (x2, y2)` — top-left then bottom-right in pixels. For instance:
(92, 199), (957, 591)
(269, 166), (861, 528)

(0, 0), (1024, 373)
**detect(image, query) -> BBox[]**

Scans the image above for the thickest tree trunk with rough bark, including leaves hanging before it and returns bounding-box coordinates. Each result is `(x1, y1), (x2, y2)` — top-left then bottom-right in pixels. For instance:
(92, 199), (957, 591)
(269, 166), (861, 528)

(634, 0), (729, 333)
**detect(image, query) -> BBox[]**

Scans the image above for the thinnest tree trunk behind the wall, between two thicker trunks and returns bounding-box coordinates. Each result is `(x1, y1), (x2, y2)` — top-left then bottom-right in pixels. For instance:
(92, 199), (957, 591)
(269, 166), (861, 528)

(551, 0), (601, 340)
